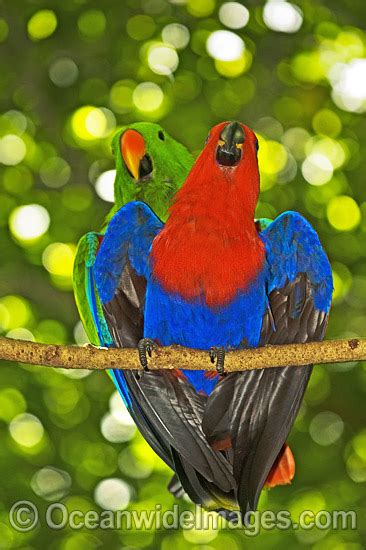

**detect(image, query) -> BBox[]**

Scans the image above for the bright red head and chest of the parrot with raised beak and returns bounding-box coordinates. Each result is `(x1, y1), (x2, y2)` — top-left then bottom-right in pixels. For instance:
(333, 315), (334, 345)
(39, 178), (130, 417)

(152, 122), (264, 306)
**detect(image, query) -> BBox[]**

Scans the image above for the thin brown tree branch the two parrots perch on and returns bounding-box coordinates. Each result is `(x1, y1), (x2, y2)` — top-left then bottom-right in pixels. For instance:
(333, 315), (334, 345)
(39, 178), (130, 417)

(0, 337), (366, 371)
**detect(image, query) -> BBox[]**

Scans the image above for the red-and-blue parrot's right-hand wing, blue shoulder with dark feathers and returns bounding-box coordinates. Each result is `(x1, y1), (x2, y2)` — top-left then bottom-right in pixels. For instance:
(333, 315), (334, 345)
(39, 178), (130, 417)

(203, 212), (333, 513)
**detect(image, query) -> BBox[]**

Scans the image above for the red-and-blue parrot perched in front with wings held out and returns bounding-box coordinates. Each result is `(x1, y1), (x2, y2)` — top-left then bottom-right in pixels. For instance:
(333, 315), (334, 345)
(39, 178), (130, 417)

(93, 122), (333, 519)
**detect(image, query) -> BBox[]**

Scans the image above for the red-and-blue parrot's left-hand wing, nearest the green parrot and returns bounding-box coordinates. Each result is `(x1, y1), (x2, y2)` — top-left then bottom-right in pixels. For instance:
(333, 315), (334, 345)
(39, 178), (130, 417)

(94, 202), (234, 507)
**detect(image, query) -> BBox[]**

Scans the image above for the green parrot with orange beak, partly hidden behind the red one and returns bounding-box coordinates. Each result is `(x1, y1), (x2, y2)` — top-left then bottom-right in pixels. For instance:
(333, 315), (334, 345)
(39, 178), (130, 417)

(73, 122), (194, 345)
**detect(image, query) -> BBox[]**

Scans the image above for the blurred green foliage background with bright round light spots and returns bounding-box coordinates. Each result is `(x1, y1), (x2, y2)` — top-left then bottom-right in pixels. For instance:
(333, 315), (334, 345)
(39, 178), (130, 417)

(0, 0), (366, 550)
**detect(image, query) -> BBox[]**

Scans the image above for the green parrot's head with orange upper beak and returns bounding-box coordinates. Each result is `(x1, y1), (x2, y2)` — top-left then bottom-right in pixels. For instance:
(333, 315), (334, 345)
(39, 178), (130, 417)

(112, 122), (194, 220)
